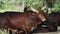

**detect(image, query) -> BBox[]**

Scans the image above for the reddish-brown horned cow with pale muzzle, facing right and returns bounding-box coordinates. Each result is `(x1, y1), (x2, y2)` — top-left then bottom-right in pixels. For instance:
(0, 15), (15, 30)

(0, 10), (45, 34)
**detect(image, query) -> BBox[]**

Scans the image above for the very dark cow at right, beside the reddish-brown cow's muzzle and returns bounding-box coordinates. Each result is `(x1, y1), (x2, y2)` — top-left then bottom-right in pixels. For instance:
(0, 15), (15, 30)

(42, 12), (60, 32)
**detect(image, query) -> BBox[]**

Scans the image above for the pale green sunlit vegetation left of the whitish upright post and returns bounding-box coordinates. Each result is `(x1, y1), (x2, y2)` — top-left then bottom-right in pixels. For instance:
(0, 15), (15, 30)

(0, 0), (21, 12)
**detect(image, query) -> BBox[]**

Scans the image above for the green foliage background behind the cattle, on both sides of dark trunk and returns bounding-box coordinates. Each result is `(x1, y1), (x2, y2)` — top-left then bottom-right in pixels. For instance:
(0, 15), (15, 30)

(0, 0), (60, 12)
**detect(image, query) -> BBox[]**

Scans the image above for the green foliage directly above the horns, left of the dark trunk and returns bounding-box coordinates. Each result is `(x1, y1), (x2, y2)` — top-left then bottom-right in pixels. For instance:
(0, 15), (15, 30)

(25, 0), (45, 9)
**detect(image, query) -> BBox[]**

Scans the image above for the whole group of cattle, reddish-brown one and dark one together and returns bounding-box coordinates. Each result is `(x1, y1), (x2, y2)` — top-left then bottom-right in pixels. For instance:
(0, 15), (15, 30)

(0, 6), (60, 34)
